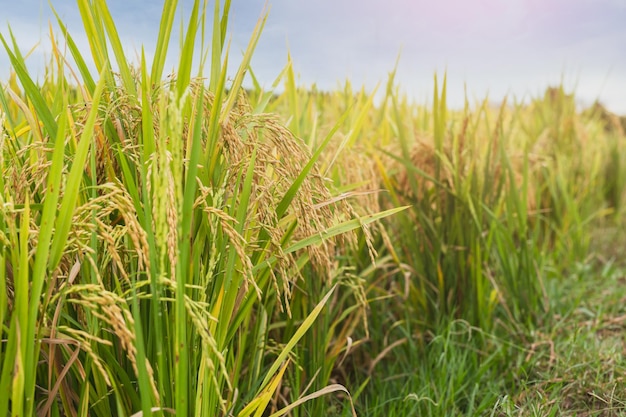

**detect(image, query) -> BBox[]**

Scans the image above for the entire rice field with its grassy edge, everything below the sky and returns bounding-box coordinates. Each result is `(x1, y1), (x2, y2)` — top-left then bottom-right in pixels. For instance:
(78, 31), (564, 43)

(0, 0), (626, 417)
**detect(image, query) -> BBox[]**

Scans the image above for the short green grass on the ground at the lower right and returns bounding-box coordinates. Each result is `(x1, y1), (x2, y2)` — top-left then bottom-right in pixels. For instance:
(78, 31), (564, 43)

(342, 245), (626, 416)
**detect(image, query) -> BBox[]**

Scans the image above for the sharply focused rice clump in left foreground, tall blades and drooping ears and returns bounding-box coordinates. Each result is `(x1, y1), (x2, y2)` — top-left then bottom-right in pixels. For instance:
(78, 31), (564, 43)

(0, 0), (401, 416)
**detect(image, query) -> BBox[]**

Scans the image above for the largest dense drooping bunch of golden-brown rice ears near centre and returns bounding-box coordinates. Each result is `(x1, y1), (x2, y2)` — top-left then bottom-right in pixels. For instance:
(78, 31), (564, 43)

(216, 95), (352, 305)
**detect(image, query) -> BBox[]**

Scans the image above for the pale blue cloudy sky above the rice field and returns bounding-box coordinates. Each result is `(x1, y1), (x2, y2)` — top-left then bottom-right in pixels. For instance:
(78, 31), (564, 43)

(0, 0), (626, 115)
